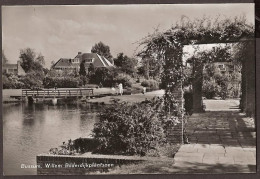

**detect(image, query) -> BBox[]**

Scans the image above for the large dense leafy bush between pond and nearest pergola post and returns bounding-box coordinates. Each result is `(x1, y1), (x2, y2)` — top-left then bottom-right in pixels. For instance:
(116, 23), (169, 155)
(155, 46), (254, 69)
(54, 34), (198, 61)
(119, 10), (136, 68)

(93, 98), (178, 156)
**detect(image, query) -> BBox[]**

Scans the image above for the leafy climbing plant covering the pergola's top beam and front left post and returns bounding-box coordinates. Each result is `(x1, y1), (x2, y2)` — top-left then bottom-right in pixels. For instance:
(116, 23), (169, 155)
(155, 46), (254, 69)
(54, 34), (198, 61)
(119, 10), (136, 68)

(138, 17), (254, 131)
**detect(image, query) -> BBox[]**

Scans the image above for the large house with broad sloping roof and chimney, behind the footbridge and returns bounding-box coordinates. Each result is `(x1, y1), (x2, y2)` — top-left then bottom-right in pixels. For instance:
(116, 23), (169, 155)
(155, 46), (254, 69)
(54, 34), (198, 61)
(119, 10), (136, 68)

(52, 52), (114, 72)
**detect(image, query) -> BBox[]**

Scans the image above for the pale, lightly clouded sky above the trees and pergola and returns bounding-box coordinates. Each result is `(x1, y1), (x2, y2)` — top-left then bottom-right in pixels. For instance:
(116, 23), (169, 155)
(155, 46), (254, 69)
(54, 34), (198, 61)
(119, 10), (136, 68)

(2, 4), (254, 67)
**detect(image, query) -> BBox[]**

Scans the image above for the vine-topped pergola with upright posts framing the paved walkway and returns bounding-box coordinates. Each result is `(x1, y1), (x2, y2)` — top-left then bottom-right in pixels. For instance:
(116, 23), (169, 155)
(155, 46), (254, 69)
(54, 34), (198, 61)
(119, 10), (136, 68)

(138, 17), (255, 143)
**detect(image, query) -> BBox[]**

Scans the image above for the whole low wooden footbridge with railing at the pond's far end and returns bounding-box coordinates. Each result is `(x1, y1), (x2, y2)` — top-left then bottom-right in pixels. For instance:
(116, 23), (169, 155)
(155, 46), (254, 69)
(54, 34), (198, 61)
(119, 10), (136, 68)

(10, 88), (94, 100)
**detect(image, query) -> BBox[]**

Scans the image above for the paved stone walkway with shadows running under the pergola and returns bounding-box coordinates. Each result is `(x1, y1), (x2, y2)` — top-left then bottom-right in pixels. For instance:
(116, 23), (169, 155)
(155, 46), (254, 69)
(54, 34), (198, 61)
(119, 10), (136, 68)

(173, 100), (256, 173)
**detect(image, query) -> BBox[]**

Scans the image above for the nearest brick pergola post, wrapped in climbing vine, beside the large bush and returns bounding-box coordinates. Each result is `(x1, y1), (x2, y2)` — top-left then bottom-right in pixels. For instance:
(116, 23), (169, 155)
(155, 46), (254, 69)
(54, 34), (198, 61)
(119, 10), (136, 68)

(164, 47), (184, 143)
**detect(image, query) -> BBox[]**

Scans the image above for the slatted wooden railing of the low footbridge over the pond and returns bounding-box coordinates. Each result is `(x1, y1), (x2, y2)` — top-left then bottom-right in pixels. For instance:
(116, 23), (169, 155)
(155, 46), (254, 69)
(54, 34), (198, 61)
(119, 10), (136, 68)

(22, 88), (94, 97)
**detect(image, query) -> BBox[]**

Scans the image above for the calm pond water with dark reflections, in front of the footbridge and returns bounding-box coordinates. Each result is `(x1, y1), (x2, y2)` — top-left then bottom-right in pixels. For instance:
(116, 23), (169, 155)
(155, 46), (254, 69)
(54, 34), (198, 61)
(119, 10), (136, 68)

(3, 103), (102, 175)
